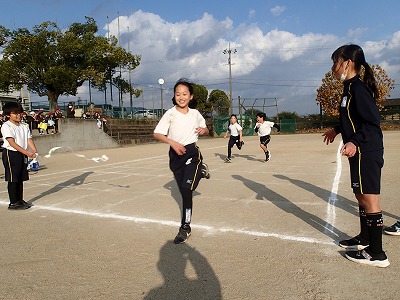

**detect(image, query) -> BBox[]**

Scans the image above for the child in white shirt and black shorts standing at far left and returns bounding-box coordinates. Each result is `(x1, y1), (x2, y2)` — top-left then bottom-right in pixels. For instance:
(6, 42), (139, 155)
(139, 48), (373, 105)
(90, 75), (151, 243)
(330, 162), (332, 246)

(1, 102), (38, 210)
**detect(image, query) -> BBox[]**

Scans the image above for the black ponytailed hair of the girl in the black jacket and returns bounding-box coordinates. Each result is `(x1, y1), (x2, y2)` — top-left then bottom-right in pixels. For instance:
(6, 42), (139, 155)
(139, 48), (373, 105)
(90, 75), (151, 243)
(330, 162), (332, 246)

(331, 44), (379, 100)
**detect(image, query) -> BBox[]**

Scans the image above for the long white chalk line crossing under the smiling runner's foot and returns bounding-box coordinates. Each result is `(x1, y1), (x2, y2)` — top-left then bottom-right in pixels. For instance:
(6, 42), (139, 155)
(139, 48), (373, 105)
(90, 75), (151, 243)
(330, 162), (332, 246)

(0, 201), (336, 246)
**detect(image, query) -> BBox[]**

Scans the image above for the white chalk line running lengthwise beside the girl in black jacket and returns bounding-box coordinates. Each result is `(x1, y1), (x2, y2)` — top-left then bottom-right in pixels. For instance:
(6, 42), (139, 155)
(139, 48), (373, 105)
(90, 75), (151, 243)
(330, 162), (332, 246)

(324, 141), (343, 233)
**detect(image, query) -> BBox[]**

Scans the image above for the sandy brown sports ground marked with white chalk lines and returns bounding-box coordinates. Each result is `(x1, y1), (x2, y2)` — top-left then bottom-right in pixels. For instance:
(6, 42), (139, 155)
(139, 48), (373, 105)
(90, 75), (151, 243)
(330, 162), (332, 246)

(0, 131), (400, 300)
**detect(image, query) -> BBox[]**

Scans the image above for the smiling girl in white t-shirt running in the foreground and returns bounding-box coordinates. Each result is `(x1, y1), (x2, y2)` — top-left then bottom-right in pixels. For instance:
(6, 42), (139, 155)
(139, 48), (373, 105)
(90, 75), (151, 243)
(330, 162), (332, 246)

(154, 79), (210, 244)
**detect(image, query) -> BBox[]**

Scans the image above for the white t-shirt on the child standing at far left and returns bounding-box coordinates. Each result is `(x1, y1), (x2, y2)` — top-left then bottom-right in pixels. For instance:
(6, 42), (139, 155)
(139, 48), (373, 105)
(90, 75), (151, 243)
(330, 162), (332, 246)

(1, 121), (32, 151)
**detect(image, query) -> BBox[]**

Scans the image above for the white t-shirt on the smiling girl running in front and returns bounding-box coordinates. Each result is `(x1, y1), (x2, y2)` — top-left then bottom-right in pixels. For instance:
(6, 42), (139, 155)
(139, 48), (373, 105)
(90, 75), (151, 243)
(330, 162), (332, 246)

(154, 106), (207, 146)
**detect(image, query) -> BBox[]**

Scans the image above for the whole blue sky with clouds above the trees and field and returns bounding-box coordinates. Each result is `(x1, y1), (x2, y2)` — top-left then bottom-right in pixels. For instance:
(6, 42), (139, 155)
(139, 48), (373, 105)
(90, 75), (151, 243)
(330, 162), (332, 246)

(0, 0), (400, 116)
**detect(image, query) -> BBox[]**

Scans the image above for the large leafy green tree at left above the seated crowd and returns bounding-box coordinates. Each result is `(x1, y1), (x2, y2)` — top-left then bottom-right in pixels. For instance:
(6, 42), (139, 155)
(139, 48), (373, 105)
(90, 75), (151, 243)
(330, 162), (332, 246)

(0, 17), (141, 110)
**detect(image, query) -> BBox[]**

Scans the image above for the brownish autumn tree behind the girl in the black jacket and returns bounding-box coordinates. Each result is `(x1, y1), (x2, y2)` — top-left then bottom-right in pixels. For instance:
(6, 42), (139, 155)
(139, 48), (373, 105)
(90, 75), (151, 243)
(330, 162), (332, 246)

(316, 65), (394, 116)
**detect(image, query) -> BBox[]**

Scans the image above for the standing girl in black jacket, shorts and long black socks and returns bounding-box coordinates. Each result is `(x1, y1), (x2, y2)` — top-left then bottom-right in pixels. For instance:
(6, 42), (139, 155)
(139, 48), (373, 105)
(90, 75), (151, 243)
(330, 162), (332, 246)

(323, 45), (389, 267)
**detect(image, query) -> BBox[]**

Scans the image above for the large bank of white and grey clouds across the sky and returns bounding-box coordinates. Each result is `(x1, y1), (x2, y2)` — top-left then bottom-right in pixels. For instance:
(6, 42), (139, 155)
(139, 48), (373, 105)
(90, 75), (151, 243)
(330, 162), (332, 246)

(88, 8), (400, 115)
